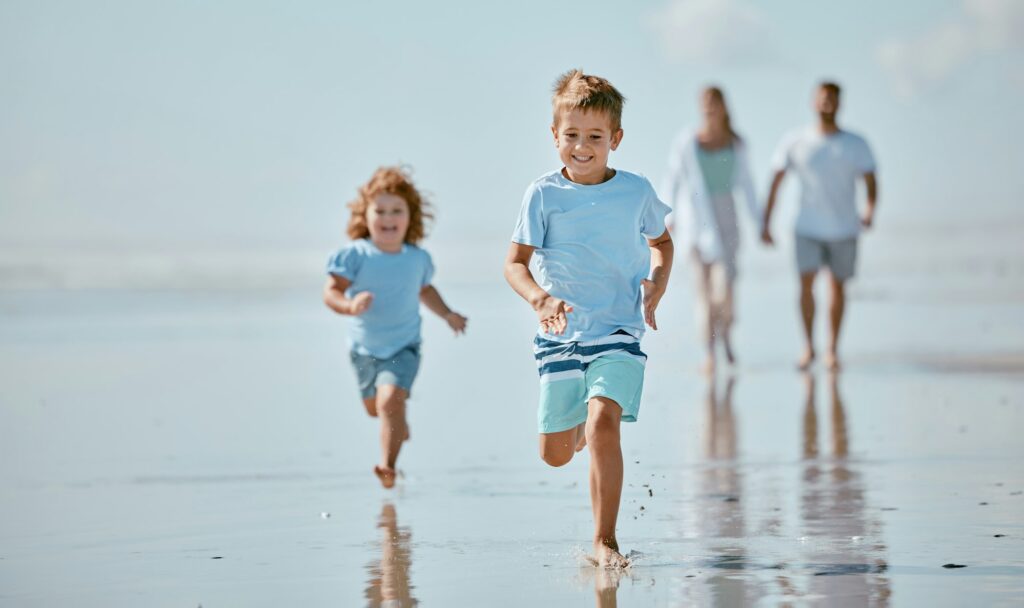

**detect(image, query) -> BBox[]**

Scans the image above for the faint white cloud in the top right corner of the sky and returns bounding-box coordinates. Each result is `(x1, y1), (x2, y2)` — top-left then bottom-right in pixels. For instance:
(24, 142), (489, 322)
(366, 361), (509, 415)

(876, 0), (1024, 97)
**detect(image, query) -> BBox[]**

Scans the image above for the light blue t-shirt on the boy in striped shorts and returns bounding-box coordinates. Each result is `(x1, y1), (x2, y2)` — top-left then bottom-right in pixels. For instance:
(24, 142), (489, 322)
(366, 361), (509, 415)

(512, 171), (671, 342)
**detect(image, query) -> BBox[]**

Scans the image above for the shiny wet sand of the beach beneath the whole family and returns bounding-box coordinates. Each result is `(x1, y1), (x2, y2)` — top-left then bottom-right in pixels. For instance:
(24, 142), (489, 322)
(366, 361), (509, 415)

(0, 225), (1024, 607)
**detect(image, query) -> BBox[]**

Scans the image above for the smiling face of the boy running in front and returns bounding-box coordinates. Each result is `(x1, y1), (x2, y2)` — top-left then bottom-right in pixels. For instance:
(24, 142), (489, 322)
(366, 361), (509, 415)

(551, 108), (623, 184)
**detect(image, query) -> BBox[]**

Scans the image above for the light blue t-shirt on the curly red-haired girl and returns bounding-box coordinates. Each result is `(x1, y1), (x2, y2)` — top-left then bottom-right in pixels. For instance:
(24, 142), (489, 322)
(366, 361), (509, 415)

(327, 238), (434, 359)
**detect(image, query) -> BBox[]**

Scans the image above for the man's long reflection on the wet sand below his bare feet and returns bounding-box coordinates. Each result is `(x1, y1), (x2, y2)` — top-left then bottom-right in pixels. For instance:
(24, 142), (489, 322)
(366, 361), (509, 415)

(791, 374), (891, 606)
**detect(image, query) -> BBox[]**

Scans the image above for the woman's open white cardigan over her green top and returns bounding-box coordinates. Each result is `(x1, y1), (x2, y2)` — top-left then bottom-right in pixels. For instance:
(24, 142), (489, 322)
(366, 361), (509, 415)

(663, 130), (762, 262)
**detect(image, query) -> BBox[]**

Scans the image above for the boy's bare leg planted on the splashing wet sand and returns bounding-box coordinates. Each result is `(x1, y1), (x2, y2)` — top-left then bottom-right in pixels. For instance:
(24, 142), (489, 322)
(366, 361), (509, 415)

(587, 397), (628, 568)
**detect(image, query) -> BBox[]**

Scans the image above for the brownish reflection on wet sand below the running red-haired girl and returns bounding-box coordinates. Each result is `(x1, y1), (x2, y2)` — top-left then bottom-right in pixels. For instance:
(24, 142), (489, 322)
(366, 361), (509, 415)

(366, 503), (419, 608)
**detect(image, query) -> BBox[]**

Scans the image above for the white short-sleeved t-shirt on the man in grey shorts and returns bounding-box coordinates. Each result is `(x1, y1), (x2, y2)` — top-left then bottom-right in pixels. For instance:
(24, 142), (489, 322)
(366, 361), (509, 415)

(771, 127), (874, 241)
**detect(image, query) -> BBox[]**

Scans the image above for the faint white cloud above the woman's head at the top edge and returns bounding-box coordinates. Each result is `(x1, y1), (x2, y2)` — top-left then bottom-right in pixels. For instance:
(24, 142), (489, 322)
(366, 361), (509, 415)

(648, 0), (774, 68)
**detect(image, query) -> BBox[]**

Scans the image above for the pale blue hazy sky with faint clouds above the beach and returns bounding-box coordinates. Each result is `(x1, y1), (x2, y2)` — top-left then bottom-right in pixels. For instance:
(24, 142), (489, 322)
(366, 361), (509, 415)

(0, 0), (1024, 249)
